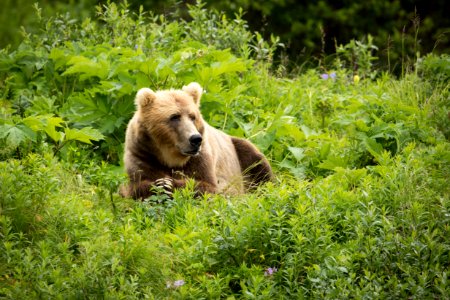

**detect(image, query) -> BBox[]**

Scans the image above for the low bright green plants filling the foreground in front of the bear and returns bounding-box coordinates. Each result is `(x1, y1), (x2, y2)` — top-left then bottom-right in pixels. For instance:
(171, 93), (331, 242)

(0, 140), (450, 299)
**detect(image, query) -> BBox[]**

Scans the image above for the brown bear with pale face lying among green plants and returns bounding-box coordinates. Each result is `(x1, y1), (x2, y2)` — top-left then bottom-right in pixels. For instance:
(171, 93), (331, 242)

(121, 82), (273, 199)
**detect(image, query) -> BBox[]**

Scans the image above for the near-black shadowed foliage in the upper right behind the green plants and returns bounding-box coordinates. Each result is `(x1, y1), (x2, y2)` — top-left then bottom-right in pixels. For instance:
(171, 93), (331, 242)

(205, 0), (450, 74)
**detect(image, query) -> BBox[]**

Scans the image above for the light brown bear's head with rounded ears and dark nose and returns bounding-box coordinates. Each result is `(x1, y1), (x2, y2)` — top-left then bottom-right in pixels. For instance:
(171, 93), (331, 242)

(135, 82), (205, 167)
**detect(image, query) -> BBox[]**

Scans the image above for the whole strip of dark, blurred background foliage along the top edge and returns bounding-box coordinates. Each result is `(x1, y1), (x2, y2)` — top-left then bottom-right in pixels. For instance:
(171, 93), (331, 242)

(0, 0), (450, 73)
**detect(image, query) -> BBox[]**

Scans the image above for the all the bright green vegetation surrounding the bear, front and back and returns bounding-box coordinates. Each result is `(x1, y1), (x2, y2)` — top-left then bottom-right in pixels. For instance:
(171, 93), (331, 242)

(0, 4), (450, 299)
